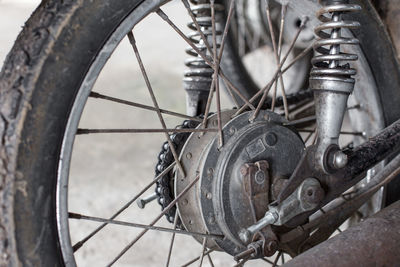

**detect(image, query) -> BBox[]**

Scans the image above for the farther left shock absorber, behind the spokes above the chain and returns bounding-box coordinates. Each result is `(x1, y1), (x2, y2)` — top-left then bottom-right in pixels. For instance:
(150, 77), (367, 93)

(183, 0), (224, 116)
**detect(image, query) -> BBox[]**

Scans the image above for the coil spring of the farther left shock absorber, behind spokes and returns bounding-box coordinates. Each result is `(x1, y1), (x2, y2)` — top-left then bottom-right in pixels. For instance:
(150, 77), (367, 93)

(184, 0), (224, 100)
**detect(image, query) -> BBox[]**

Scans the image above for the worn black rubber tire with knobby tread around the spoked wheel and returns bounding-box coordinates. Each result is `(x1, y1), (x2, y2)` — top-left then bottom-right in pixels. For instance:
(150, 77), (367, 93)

(0, 0), (400, 266)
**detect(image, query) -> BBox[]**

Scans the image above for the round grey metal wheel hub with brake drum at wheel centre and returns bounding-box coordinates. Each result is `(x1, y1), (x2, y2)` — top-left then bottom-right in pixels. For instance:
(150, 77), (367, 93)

(175, 111), (304, 255)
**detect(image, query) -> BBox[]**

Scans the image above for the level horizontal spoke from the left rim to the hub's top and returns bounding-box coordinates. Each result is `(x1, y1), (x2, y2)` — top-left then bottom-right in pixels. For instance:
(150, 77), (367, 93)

(76, 128), (218, 135)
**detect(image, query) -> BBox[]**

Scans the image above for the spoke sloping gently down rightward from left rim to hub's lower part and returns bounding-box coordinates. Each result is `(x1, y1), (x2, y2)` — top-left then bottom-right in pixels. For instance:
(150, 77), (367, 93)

(68, 212), (220, 239)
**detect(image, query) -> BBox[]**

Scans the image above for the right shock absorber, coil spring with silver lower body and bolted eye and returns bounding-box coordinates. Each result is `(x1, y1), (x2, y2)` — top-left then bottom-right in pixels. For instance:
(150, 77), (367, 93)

(310, 0), (361, 173)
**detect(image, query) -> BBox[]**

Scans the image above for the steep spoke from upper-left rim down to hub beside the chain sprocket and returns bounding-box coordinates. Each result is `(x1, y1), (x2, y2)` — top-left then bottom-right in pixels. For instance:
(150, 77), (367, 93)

(128, 31), (186, 176)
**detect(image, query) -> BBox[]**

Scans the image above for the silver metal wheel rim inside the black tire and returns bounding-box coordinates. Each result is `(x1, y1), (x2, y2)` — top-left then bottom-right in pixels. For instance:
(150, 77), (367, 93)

(57, 1), (383, 266)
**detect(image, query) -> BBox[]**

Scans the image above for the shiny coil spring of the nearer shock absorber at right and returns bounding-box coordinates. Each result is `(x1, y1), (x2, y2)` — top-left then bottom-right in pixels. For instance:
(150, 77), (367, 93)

(311, 1), (361, 81)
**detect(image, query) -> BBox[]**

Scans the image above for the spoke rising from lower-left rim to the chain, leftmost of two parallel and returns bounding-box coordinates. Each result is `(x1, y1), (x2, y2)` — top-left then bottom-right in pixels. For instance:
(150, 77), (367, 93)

(72, 163), (175, 252)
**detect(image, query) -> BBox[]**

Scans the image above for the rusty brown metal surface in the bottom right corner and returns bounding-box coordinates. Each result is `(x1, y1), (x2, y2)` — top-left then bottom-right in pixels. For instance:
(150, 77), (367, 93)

(284, 201), (400, 267)
